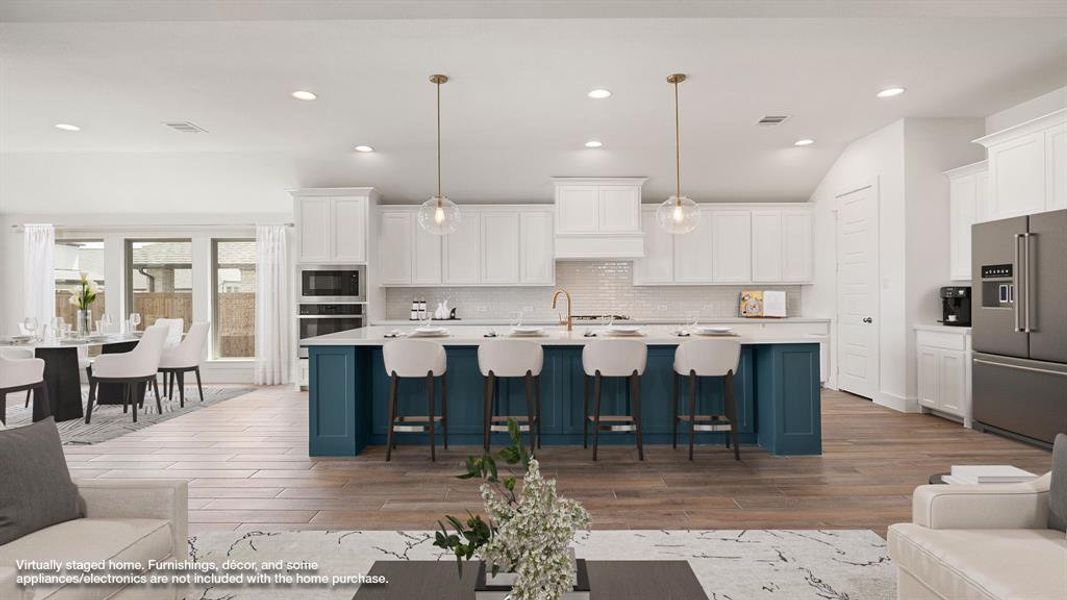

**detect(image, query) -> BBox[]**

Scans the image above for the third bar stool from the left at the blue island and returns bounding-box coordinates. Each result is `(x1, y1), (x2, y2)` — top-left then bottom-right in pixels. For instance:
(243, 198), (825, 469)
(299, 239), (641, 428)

(582, 340), (649, 460)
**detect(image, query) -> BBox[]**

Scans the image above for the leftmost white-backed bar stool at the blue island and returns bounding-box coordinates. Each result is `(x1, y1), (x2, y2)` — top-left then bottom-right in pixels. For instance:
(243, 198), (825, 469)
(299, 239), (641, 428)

(382, 340), (448, 461)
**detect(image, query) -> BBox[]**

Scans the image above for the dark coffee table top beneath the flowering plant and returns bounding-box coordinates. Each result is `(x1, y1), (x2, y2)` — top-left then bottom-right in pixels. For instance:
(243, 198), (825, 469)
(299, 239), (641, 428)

(353, 559), (708, 600)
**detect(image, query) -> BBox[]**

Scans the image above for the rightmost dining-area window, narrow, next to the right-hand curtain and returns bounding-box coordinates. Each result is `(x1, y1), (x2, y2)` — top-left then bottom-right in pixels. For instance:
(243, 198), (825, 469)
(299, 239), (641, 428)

(211, 239), (256, 359)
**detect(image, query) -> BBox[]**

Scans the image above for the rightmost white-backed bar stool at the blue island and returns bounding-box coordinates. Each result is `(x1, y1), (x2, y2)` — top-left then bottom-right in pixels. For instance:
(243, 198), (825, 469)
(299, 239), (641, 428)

(671, 340), (740, 460)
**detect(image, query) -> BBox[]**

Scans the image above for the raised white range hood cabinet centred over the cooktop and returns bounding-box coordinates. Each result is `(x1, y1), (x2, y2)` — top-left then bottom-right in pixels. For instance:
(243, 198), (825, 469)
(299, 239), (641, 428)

(553, 177), (644, 258)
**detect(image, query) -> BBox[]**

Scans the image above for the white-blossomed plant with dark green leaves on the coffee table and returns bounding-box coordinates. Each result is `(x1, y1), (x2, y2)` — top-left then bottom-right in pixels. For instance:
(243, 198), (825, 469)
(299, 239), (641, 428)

(433, 420), (590, 600)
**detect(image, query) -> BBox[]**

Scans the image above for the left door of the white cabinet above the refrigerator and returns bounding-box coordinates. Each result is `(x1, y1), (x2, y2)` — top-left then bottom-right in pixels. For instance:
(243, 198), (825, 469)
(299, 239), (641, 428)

(989, 131), (1046, 219)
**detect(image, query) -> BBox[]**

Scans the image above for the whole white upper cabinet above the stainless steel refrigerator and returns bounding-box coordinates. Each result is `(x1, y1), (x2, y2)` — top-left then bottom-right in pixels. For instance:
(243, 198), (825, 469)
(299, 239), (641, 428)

(977, 109), (1067, 220)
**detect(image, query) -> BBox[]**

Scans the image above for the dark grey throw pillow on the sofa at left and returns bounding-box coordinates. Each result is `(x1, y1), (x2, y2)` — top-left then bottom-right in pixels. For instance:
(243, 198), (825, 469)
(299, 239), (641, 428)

(0, 416), (84, 546)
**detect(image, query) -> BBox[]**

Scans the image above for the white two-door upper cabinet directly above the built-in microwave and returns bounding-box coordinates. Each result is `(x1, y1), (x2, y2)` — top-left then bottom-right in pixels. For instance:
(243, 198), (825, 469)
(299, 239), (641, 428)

(290, 188), (378, 264)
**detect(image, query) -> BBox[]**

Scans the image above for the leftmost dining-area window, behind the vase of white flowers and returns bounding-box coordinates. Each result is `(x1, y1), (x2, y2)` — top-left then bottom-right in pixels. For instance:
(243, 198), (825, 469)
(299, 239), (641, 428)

(54, 239), (107, 327)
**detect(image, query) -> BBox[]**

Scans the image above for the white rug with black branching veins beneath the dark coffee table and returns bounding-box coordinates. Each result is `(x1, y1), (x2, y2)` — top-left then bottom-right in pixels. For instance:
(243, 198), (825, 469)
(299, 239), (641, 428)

(185, 530), (896, 600)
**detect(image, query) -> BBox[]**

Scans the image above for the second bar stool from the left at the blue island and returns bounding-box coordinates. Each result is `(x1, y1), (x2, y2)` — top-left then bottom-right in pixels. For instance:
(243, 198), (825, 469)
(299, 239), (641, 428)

(478, 340), (544, 453)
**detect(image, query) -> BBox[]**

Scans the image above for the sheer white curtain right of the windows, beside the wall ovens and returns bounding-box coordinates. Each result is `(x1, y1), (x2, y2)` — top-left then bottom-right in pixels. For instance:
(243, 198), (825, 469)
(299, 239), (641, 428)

(255, 225), (292, 385)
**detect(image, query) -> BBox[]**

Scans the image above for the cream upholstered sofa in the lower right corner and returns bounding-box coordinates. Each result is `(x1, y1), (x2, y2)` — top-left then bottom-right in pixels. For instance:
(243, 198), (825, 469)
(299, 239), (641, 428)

(889, 474), (1067, 600)
